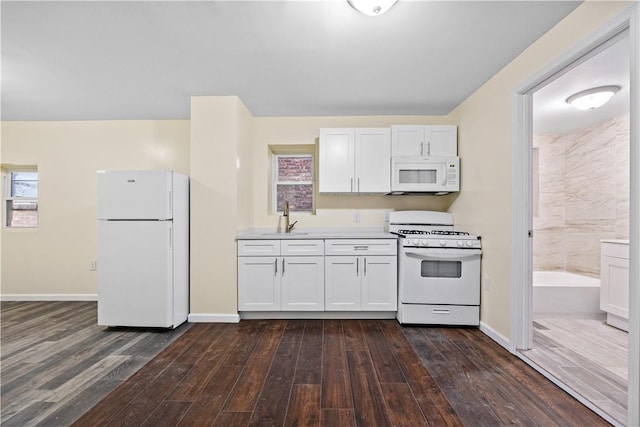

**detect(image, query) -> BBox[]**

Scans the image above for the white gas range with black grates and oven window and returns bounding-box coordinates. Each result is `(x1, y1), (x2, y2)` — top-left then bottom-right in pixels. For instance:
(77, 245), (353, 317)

(386, 211), (482, 326)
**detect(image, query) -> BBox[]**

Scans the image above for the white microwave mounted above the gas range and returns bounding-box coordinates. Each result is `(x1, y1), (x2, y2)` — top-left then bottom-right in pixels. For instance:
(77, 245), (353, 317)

(391, 156), (460, 194)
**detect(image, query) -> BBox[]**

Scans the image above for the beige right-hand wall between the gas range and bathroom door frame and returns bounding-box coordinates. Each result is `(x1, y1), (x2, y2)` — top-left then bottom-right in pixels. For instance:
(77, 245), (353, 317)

(448, 1), (632, 338)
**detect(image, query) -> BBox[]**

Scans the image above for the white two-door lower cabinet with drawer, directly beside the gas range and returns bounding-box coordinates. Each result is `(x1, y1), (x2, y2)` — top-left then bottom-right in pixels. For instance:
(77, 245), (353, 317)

(324, 239), (398, 311)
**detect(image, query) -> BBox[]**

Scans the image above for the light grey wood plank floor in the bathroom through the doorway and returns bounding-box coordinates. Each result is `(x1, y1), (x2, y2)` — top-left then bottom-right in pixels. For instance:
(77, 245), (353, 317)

(522, 318), (629, 425)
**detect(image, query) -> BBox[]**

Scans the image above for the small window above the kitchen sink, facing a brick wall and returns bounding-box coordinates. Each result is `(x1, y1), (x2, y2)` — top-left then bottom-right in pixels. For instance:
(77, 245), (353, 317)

(273, 154), (313, 212)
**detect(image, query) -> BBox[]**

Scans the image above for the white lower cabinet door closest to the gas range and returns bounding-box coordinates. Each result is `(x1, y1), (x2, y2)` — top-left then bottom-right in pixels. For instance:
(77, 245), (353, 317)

(362, 256), (398, 311)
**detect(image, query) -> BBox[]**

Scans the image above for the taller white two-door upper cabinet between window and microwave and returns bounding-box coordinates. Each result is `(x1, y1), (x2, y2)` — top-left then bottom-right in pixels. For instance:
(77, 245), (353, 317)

(319, 128), (391, 193)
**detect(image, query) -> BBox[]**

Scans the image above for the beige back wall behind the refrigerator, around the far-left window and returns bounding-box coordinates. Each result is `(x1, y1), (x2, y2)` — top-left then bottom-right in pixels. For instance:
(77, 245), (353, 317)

(2, 120), (189, 295)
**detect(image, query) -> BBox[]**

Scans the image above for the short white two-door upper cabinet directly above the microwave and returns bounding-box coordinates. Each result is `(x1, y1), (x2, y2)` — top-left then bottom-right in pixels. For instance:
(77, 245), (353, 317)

(391, 125), (458, 157)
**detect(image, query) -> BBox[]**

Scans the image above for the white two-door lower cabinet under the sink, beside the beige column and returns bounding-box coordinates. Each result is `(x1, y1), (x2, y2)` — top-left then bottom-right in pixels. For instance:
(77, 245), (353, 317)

(238, 240), (324, 311)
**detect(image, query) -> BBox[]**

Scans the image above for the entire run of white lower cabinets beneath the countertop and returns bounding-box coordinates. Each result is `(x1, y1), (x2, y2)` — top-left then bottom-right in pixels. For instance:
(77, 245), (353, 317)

(238, 239), (398, 311)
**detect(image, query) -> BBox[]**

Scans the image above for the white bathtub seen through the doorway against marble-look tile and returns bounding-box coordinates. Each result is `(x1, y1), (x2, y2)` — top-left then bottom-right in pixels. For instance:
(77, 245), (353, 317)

(533, 271), (604, 319)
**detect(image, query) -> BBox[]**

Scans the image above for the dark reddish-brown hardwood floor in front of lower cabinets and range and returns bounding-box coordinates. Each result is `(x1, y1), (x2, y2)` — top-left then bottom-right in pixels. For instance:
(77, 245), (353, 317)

(2, 303), (608, 427)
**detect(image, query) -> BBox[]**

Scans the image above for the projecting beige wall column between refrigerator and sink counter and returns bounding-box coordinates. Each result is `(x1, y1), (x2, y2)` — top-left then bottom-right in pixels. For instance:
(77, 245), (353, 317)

(190, 96), (251, 315)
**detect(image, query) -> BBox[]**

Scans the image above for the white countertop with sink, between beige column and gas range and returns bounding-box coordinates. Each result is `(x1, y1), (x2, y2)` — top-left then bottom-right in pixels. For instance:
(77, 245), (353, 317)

(236, 227), (398, 240)
